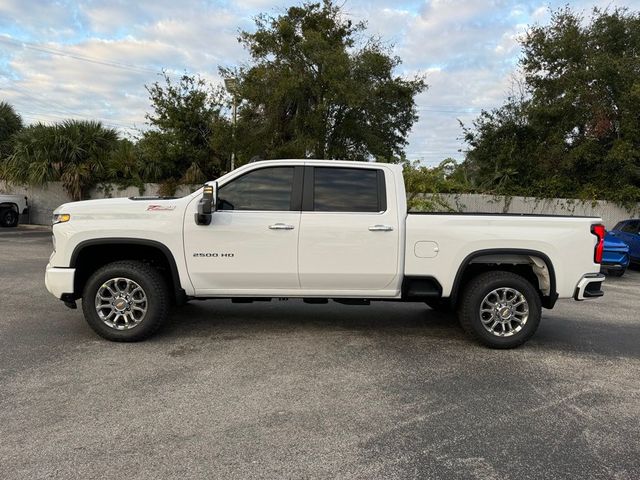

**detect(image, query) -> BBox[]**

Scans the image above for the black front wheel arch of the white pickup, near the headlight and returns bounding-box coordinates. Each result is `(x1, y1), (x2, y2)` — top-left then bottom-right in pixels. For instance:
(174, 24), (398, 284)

(69, 238), (186, 304)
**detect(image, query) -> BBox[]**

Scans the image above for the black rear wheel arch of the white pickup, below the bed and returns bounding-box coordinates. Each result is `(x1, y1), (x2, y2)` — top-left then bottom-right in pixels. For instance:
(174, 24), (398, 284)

(450, 248), (558, 308)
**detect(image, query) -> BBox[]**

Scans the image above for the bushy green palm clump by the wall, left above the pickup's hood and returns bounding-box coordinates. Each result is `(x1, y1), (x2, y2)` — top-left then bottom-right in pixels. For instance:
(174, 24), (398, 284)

(5, 120), (118, 200)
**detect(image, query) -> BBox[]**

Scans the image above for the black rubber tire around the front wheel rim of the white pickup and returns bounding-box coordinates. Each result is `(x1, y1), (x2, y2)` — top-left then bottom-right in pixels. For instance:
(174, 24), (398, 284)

(82, 260), (170, 342)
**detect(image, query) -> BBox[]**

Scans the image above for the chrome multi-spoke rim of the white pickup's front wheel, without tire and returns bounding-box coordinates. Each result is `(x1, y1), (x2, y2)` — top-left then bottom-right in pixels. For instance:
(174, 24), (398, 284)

(95, 278), (149, 330)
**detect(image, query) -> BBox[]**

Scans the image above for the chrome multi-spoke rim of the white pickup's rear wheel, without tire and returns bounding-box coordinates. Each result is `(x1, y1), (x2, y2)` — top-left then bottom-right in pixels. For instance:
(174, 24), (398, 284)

(480, 287), (529, 337)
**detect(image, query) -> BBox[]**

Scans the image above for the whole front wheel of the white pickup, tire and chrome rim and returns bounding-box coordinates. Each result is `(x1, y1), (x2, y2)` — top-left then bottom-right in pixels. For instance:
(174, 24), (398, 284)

(82, 261), (169, 342)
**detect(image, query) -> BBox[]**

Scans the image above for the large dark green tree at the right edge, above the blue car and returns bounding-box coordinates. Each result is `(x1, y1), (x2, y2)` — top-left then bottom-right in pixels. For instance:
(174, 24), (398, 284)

(465, 8), (640, 202)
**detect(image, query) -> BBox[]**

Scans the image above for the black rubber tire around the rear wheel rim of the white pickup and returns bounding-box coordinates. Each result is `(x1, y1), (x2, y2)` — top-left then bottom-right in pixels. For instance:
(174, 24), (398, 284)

(458, 271), (542, 348)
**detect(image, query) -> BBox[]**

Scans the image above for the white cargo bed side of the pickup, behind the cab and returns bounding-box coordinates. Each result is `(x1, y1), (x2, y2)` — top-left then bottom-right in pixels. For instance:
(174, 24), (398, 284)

(404, 212), (601, 298)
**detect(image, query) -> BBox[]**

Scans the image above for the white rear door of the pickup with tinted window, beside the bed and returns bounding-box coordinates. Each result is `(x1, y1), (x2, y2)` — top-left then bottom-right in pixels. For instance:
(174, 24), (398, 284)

(298, 166), (400, 295)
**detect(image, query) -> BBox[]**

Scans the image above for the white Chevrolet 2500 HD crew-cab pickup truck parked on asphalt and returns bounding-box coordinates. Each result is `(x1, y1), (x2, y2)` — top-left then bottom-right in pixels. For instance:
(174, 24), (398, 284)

(45, 160), (604, 348)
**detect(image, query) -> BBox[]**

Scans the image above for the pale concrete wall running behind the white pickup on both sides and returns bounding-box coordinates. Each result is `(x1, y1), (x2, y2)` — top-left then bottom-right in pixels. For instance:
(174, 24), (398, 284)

(0, 182), (640, 228)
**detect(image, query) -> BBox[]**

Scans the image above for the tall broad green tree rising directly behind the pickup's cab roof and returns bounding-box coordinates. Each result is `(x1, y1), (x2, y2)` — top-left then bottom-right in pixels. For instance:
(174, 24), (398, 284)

(221, 0), (426, 163)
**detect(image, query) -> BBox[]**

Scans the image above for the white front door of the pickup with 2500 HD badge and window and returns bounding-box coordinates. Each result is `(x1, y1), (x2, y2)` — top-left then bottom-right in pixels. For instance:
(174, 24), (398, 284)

(184, 166), (302, 295)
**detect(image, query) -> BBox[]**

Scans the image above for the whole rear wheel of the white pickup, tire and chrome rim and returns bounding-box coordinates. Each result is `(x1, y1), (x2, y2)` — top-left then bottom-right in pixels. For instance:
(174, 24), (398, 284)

(458, 271), (542, 348)
